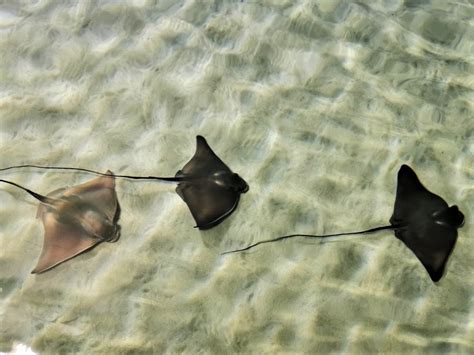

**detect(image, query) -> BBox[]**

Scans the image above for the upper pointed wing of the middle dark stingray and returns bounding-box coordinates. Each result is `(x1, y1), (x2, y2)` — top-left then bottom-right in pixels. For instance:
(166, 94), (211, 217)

(178, 136), (231, 177)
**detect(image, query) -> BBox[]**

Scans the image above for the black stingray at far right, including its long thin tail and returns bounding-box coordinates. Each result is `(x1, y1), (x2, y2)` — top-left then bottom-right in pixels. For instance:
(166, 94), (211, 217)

(223, 165), (464, 282)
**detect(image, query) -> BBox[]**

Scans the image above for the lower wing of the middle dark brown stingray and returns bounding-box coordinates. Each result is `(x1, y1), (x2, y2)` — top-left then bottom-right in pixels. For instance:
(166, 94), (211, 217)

(176, 179), (240, 229)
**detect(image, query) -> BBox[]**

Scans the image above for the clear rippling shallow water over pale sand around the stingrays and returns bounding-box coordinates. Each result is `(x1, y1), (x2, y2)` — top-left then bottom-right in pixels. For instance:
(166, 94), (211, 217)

(0, 0), (474, 354)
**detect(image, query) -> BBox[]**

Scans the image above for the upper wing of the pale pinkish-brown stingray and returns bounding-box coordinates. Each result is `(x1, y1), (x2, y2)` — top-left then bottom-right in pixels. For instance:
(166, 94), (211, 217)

(63, 170), (118, 221)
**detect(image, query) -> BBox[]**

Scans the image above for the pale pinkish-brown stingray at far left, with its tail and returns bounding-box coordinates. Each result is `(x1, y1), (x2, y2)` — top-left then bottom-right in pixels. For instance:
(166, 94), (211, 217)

(0, 171), (120, 274)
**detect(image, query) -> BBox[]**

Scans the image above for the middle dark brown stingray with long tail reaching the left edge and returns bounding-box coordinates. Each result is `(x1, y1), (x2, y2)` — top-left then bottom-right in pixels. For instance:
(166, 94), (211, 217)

(0, 136), (249, 230)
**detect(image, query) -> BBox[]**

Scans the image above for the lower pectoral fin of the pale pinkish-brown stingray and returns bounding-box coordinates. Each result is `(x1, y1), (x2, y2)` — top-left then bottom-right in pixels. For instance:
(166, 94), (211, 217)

(32, 213), (101, 274)
